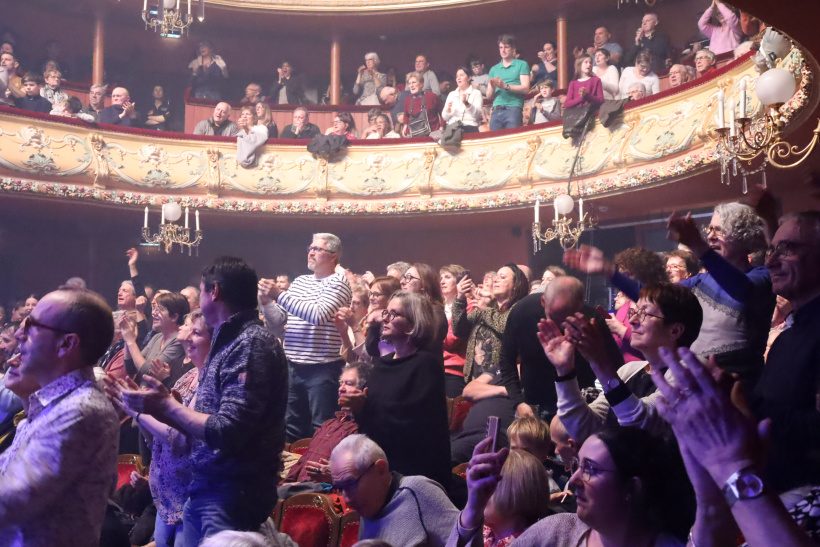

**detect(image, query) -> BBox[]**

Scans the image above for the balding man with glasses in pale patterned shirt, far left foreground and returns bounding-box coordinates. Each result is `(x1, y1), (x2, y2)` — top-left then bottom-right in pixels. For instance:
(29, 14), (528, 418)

(0, 289), (119, 546)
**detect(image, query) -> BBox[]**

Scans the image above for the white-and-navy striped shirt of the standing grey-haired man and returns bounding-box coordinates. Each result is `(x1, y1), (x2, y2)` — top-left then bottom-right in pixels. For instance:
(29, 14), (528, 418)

(277, 273), (353, 365)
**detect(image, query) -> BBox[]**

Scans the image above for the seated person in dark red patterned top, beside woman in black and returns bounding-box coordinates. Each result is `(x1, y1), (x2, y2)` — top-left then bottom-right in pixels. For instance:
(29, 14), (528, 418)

(280, 361), (372, 484)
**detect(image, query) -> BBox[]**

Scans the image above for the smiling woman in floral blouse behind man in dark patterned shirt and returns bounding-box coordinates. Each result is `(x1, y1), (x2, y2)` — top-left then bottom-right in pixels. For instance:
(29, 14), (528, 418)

(105, 310), (213, 546)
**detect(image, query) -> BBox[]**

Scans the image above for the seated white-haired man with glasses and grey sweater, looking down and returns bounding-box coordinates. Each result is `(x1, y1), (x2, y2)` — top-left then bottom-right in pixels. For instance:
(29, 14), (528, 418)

(330, 435), (459, 547)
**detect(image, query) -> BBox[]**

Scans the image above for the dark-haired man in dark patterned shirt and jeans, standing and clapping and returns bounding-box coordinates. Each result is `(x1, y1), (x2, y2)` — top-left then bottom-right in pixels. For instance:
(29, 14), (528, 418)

(122, 257), (287, 545)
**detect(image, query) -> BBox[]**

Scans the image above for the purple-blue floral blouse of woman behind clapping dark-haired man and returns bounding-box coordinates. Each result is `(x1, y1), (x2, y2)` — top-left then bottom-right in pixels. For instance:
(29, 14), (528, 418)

(148, 368), (199, 524)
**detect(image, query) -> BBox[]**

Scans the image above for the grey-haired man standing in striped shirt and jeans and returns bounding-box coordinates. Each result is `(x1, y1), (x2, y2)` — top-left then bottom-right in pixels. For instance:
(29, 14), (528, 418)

(260, 234), (352, 441)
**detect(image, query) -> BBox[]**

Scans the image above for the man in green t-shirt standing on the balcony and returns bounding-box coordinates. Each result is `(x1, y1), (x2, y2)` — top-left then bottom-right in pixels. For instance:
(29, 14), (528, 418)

(487, 34), (530, 131)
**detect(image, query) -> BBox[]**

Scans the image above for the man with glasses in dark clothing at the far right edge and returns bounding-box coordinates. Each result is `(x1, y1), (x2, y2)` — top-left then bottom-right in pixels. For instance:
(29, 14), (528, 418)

(749, 211), (820, 492)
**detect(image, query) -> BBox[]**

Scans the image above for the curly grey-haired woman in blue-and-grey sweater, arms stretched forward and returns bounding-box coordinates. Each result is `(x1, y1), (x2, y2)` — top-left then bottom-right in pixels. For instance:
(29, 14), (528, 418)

(564, 203), (775, 383)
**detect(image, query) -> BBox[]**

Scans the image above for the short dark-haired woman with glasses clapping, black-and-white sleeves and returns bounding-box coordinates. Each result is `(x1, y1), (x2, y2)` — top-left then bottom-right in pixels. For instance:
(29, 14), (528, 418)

(538, 283), (703, 442)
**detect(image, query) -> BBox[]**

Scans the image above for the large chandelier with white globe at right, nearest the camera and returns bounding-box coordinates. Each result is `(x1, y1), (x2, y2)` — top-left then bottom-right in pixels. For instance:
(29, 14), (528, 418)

(715, 68), (820, 194)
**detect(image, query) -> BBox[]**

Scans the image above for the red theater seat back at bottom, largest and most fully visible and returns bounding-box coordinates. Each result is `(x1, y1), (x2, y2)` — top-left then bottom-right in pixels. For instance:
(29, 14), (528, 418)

(279, 494), (339, 547)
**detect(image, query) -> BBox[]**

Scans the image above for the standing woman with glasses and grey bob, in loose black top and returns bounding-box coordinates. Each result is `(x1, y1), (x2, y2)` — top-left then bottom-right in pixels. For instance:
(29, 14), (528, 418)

(347, 294), (452, 488)
